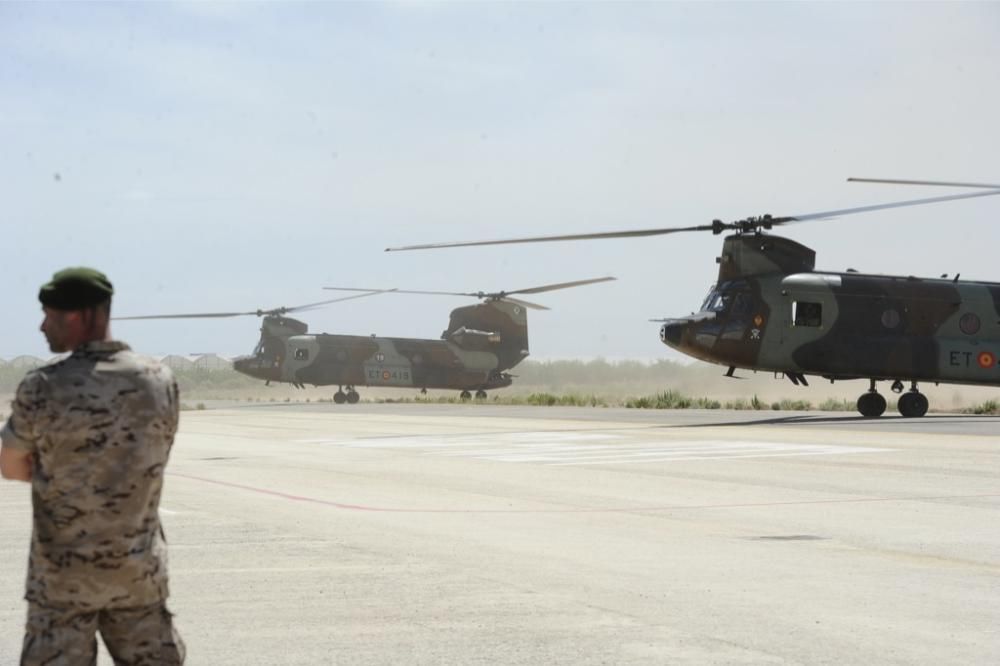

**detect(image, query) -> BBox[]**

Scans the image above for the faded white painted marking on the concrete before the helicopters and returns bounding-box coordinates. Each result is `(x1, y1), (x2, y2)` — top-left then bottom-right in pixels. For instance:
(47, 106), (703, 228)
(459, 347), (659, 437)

(296, 431), (894, 467)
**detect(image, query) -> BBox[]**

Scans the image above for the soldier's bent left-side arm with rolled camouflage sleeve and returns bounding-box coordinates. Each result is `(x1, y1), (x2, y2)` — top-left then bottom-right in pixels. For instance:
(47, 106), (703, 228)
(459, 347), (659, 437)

(0, 373), (46, 481)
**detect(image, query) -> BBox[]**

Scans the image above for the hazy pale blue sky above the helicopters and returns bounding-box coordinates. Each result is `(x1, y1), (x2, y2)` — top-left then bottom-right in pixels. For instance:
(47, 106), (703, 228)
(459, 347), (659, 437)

(0, 2), (1000, 358)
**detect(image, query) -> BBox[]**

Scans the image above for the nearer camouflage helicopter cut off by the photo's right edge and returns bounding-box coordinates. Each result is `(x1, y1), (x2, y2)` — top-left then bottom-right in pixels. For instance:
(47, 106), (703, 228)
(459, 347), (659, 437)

(386, 179), (1000, 417)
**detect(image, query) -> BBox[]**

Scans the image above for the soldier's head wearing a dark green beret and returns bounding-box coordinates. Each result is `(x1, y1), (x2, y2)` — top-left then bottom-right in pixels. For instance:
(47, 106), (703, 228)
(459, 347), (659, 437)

(38, 266), (114, 353)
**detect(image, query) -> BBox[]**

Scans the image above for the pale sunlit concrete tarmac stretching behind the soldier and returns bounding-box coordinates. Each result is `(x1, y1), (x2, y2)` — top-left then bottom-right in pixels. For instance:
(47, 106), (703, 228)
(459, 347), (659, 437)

(0, 404), (1000, 665)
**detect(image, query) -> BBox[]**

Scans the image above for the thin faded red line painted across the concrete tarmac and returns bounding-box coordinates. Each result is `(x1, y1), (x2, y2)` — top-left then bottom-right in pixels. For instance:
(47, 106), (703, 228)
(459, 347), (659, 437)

(168, 472), (1000, 513)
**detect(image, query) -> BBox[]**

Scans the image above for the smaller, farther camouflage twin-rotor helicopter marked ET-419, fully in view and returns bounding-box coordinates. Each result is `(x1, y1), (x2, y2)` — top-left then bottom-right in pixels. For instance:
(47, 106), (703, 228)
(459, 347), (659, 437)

(121, 277), (615, 404)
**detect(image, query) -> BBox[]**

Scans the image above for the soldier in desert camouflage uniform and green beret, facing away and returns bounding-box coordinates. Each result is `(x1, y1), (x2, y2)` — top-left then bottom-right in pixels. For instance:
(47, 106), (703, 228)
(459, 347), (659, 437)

(0, 268), (184, 666)
